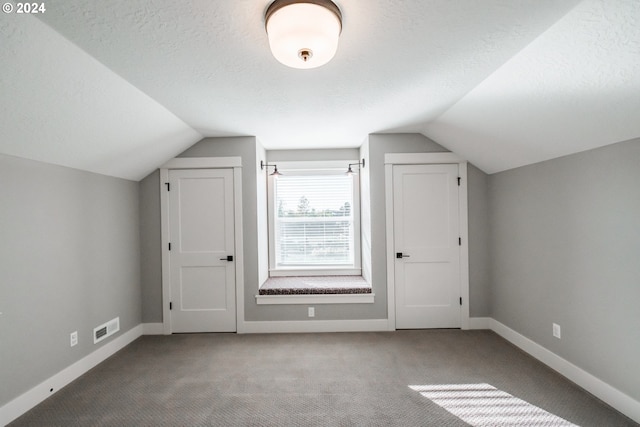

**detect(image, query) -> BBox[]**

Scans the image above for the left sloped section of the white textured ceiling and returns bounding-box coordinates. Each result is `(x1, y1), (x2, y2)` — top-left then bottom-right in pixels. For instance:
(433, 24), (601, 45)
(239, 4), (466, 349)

(0, 14), (202, 180)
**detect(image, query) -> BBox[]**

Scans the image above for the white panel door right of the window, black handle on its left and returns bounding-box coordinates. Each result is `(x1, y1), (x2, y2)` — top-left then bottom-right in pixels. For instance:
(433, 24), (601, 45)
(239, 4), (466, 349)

(393, 164), (461, 329)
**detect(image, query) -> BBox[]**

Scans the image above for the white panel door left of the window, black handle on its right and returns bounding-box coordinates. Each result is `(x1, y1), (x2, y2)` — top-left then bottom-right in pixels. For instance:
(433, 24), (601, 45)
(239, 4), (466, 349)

(169, 169), (236, 332)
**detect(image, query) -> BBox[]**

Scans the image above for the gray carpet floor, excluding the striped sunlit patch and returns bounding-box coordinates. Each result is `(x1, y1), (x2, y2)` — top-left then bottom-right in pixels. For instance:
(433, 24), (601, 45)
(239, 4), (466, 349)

(10, 330), (638, 427)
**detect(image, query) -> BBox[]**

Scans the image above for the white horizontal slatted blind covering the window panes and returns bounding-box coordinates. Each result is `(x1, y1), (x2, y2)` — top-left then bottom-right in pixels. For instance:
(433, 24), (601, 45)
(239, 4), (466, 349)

(274, 174), (354, 268)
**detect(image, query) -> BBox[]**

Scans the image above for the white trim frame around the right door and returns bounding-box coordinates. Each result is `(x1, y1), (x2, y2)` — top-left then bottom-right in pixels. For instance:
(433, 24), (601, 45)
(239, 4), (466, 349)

(384, 153), (469, 331)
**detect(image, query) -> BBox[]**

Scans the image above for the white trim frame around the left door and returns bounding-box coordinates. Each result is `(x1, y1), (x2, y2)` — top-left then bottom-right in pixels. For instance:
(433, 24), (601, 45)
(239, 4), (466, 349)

(160, 157), (244, 335)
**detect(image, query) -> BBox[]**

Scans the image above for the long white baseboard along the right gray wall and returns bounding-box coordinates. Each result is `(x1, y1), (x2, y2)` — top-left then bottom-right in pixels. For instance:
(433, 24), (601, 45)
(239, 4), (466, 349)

(489, 319), (640, 423)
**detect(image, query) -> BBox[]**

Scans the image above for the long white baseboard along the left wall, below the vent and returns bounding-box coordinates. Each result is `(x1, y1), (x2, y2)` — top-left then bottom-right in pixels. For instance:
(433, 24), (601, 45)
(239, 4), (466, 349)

(0, 325), (143, 426)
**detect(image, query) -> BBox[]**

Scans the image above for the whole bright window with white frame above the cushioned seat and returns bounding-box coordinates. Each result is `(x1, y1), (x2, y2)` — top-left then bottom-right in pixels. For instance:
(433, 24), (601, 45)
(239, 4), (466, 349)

(269, 161), (361, 276)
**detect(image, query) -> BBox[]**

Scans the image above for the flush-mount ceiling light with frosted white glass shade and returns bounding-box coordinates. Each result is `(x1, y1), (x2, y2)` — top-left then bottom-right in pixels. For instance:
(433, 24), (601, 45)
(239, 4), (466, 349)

(265, 0), (342, 69)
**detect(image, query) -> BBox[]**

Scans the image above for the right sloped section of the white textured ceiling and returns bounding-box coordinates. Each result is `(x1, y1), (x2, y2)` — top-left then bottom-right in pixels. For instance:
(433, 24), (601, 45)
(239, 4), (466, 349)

(422, 0), (640, 173)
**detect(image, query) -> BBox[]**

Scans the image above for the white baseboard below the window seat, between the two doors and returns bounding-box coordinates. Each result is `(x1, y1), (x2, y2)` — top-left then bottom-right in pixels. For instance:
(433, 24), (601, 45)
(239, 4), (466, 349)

(238, 319), (389, 334)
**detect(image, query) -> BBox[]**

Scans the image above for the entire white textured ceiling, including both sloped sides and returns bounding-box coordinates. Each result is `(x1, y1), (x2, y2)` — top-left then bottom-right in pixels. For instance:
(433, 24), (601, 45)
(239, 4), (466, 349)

(0, 0), (640, 180)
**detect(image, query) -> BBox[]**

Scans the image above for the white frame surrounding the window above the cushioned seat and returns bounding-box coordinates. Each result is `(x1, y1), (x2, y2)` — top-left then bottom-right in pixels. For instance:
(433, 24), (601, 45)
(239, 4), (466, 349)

(267, 160), (362, 277)
